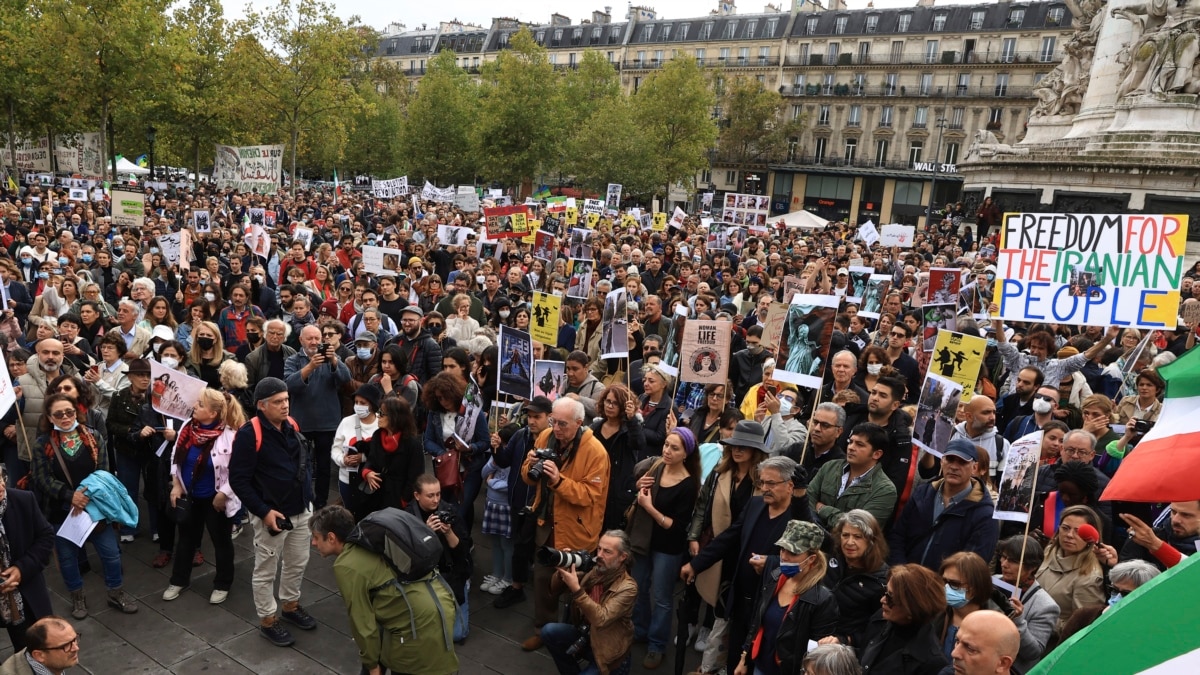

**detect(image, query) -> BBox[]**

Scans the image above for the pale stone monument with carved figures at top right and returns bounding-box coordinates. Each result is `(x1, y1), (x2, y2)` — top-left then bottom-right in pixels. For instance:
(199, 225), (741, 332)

(959, 0), (1200, 241)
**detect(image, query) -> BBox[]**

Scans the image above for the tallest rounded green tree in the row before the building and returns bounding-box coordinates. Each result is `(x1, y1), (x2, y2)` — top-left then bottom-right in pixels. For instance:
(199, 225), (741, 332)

(475, 29), (562, 190)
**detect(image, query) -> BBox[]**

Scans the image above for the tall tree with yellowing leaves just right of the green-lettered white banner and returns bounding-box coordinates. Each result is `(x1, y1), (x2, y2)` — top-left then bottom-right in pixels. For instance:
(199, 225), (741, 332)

(235, 0), (364, 193)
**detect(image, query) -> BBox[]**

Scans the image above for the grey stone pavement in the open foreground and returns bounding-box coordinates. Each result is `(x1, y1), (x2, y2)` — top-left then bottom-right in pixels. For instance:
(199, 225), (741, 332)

(0, 506), (700, 675)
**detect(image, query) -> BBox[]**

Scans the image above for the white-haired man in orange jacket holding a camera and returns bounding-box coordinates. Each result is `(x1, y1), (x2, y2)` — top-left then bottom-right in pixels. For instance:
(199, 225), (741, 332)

(521, 399), (608, 651)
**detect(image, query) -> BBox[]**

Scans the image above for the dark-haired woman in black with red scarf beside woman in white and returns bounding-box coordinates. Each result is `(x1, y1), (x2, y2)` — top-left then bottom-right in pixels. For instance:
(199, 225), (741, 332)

(358, 386), (425, 514)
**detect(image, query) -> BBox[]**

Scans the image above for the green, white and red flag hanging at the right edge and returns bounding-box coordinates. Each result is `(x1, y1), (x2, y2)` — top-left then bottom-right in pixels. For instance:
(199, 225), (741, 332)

(1100, 350), (1200, 502)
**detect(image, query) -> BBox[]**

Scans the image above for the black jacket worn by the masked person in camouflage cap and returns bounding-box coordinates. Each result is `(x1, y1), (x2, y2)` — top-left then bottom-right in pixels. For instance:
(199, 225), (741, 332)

(742, 556), (838, 673)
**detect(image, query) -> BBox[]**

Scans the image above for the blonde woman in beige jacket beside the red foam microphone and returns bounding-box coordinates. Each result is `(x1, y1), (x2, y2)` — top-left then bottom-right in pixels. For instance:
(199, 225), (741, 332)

(1034, 504), (1106, 629)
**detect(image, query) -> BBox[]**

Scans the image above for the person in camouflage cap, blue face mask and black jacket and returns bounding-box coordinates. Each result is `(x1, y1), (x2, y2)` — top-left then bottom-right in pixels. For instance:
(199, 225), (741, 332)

(730, 520), (838, 675)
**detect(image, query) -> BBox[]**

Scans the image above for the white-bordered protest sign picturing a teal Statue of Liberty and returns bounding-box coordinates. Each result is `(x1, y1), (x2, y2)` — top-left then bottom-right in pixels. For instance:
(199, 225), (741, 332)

(774, 293), (839, 389)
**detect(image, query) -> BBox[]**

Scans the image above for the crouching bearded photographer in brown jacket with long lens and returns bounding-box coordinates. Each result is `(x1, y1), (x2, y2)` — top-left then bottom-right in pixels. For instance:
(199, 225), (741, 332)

(538, 530), (637, 675)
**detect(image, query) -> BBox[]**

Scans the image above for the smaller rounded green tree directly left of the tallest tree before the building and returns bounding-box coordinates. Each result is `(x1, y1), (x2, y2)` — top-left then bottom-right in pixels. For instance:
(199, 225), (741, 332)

(401, 49), (480, 185)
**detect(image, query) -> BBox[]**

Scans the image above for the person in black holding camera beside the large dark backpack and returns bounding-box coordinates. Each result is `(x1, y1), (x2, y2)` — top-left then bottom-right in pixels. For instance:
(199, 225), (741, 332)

(407, 473), (474, 644)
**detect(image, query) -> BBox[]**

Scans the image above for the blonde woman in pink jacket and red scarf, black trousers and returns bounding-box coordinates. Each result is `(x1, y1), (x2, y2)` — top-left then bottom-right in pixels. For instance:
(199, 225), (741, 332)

(162, 389), (246, 604)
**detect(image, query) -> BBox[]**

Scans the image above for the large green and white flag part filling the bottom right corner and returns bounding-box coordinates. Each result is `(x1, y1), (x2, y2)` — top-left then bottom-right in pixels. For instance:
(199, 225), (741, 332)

(1030, 547), (1200, 675)
